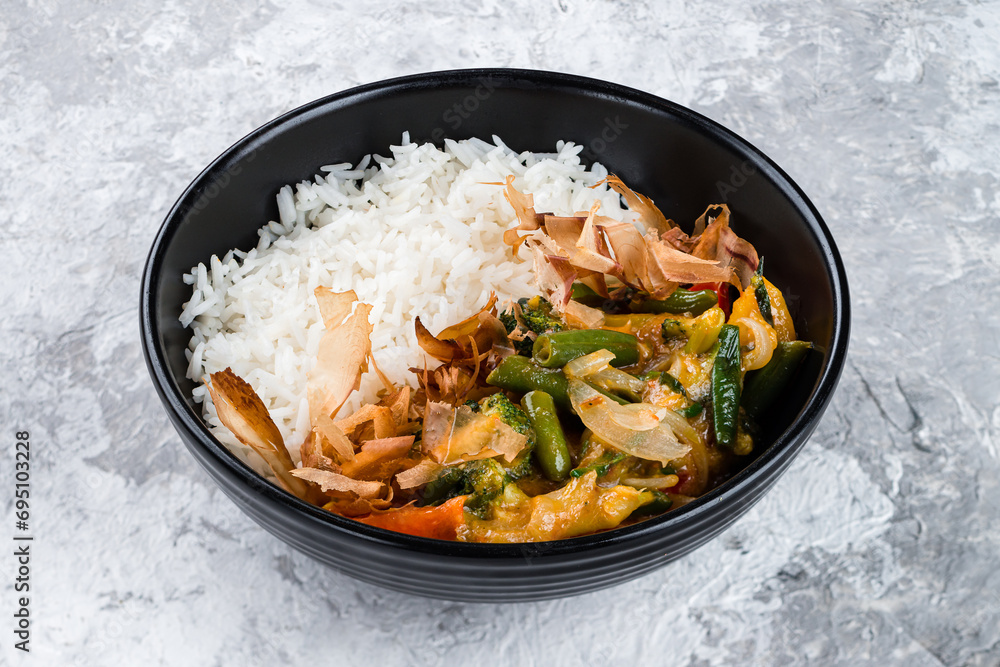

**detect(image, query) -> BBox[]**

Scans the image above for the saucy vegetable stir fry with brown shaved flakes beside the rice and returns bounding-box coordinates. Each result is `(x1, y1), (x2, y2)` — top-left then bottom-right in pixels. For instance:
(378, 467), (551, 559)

(209, 176), (811, 542)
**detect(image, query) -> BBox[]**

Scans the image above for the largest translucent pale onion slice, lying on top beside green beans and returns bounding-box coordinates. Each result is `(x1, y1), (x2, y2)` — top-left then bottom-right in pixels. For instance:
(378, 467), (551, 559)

(569, 380), (691, 465)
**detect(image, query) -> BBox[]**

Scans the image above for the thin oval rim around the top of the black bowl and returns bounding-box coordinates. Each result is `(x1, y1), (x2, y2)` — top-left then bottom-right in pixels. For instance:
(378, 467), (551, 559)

(139, 68), (850, 559)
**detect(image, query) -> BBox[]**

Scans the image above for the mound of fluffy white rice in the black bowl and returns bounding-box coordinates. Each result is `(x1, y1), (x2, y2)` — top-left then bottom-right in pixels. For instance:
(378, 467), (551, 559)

(180, 133), (628, 472)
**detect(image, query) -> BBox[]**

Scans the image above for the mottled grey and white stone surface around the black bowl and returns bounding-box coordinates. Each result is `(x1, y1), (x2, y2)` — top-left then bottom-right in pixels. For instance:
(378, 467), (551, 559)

(0, 0), (1000, 667)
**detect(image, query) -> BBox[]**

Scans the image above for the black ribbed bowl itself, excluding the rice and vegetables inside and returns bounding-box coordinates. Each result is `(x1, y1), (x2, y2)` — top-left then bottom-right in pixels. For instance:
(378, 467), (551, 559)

(141, 69), (849, 601)
